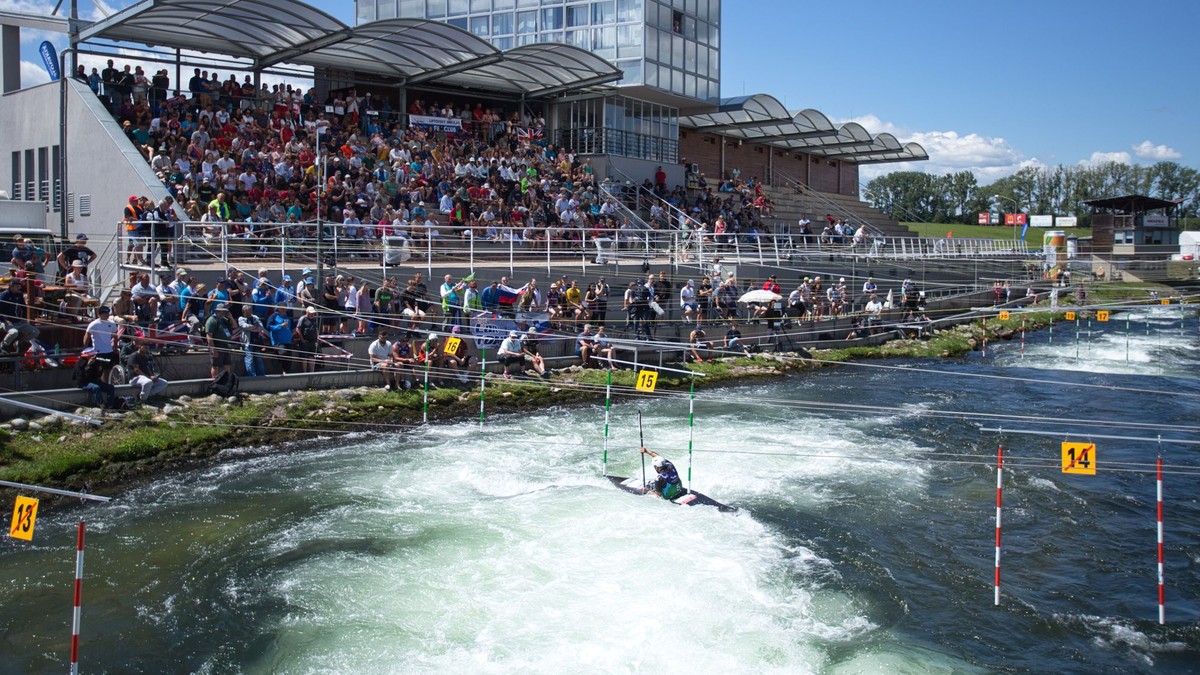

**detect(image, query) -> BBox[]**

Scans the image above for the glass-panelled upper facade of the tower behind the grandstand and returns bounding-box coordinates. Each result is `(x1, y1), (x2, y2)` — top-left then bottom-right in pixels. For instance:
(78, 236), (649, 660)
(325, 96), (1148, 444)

(356, 0), (721, 103)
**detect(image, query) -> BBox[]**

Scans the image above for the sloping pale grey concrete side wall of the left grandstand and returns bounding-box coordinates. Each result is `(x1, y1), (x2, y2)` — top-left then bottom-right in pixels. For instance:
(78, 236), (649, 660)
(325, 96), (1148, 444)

(0, 79), (175, 294)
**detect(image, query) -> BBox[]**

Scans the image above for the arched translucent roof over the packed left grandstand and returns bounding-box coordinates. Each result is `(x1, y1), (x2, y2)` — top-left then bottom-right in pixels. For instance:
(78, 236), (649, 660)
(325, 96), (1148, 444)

(79, 0), (622, 96)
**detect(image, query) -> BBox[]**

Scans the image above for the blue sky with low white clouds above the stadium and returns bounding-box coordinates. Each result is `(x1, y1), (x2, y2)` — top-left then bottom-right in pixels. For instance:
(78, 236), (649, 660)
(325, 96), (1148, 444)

(11, 0), (1200, 181)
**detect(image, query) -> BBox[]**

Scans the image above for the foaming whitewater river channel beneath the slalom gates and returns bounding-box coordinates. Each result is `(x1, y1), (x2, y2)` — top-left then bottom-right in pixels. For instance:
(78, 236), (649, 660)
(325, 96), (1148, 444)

(0, 309), (1200, 674)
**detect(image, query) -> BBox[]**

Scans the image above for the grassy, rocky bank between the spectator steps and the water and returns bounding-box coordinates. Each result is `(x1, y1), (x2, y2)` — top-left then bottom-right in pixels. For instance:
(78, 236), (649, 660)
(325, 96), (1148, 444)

(0, 285), (1176, 494)
